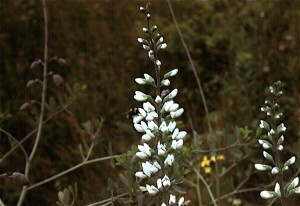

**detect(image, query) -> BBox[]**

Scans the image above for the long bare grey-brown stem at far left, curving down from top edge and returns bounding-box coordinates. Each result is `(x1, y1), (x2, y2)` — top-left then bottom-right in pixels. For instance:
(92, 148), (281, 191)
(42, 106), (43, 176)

(18, 0), (48, 203)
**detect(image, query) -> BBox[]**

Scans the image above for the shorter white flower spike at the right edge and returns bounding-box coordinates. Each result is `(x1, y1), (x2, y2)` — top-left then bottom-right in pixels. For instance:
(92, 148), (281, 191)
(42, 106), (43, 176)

(254, 81), (300, 199)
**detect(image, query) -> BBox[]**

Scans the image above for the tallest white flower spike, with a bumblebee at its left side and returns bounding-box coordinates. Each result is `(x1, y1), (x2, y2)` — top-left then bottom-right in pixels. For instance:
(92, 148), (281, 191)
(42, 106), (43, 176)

(132, 3), (187, 205)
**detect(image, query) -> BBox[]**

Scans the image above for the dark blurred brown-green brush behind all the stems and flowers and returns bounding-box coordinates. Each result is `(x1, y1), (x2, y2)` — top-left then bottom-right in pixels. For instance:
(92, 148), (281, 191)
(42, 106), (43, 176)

(0, 0), (300, 205)
